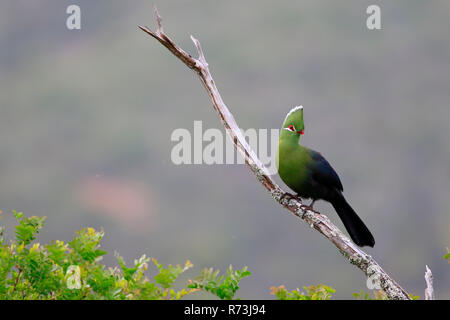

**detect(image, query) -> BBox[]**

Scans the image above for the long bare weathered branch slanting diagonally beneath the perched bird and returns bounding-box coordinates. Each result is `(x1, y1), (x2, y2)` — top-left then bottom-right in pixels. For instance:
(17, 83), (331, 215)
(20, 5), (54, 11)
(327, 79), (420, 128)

(139, 7), (411, 300)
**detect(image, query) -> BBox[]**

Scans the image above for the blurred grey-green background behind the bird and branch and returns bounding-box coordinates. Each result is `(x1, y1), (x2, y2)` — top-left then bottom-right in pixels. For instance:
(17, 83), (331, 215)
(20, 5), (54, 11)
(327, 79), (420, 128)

(0, 0), (450, 299)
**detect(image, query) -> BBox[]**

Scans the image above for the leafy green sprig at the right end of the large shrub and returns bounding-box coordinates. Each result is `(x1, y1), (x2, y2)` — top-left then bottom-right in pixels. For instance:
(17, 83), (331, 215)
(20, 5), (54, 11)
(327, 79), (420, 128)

(188, 265), (251, 300)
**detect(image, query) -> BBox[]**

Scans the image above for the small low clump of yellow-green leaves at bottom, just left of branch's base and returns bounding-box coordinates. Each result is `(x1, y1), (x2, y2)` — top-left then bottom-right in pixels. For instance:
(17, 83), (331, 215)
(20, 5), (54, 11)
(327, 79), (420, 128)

(270, 284), (336, 300)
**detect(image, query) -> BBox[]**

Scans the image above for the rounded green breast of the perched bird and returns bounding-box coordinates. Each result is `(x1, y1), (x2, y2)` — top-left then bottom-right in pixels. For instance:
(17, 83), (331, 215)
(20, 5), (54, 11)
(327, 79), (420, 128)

(276, 139), (312, 194)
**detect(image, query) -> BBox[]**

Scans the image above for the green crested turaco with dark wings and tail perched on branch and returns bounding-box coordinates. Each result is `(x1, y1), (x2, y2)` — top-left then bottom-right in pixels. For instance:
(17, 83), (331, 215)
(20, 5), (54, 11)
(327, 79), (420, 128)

(277, 106), (375, 247)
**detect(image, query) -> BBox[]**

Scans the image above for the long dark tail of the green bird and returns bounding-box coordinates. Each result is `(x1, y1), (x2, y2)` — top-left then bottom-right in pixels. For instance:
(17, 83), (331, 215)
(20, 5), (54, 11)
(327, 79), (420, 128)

(331, 193), (375, 247)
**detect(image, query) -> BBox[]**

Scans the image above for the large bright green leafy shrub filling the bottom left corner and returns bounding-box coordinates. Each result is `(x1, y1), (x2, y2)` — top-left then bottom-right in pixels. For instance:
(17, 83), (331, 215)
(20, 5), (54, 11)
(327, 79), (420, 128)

(0, 211), (250, 300)
